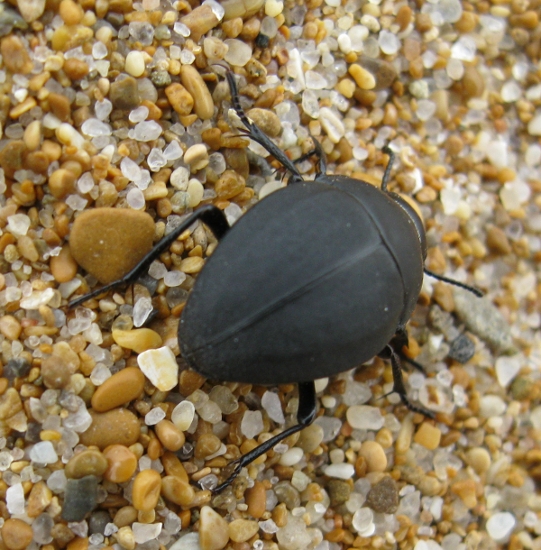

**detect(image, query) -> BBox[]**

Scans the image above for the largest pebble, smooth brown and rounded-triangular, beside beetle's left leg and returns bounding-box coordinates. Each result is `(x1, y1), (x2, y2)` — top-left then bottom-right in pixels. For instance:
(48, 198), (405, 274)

(70, 208), (154, 284)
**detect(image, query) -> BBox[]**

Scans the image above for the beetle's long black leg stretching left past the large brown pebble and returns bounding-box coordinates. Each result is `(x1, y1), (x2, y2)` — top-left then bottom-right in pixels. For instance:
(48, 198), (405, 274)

(68, 204), (229, 308)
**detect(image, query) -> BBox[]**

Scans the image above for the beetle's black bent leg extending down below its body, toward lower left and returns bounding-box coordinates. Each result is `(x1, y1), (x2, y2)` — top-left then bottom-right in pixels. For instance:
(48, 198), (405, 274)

(213, 381), (317, 493)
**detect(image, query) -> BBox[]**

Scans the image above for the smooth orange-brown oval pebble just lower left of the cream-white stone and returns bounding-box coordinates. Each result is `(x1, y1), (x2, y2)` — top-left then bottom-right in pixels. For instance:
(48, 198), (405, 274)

(91, 366), (145, 412)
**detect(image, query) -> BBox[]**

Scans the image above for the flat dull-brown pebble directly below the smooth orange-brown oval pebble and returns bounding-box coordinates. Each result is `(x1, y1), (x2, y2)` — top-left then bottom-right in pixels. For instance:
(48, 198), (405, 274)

(80, 409), (141, 449)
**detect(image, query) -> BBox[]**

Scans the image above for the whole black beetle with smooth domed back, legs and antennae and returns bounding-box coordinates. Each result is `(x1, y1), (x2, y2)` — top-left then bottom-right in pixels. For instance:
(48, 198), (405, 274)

(70, 72), (478, 491)
